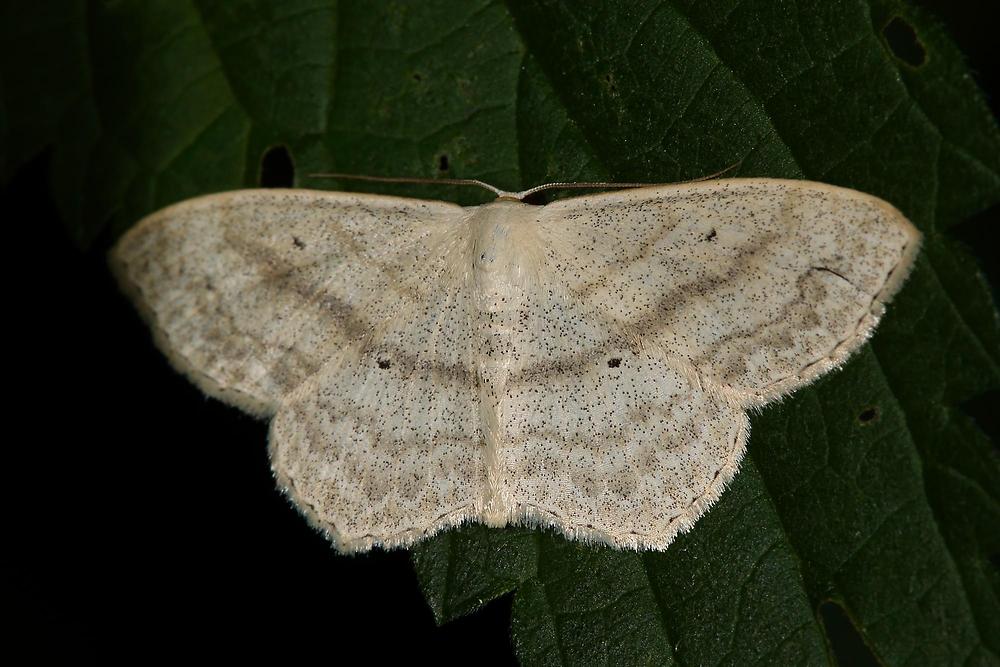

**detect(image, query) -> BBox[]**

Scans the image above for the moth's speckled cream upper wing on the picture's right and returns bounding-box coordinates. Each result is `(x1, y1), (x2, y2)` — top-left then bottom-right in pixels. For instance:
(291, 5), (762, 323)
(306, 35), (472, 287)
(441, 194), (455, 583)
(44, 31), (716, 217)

(539, 179), (920, 406)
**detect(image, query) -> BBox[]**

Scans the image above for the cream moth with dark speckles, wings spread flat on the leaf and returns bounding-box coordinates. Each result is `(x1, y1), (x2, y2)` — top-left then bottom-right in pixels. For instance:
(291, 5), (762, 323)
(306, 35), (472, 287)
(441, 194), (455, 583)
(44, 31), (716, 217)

(111, 178), (920, 552)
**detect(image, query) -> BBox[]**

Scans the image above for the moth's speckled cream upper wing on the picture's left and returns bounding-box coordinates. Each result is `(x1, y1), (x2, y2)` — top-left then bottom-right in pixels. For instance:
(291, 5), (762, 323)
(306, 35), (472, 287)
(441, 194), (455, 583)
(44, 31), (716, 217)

(111, 190), (464, 415)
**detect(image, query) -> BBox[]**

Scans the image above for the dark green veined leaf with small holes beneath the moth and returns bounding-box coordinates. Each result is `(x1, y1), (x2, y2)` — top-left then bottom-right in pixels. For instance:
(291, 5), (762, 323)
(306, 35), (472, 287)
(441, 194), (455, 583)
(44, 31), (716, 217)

(9, 0), (1000, 665)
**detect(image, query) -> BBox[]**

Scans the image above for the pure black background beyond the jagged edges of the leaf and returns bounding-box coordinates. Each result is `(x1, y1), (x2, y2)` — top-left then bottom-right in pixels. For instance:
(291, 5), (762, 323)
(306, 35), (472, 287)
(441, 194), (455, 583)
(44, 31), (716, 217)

(9, 0), (1000, 664)
